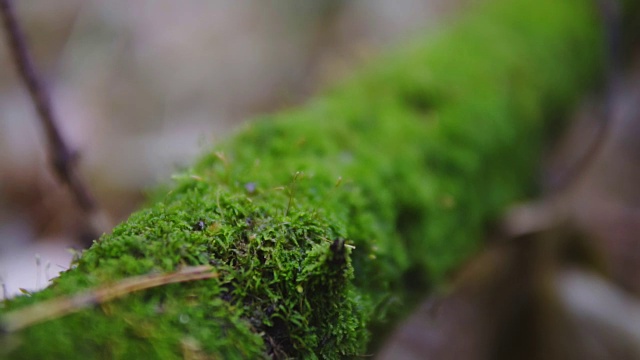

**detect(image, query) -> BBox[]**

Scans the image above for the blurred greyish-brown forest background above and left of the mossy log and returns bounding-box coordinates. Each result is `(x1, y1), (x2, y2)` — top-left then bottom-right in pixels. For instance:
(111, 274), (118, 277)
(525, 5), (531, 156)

(0, 0), (465, 296)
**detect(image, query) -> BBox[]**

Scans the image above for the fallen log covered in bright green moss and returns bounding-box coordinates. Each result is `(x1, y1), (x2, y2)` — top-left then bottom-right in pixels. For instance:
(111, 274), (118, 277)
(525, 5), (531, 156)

(0, 0), (601, 359)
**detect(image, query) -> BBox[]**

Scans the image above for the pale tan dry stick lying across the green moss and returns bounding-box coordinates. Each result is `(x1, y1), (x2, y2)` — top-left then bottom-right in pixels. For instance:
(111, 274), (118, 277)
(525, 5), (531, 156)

(0, 265), (218, 333)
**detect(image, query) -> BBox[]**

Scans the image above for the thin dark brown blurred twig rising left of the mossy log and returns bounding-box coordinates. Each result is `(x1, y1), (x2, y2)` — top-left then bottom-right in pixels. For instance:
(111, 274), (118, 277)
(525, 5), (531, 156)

(0, 0), (109, 237)
